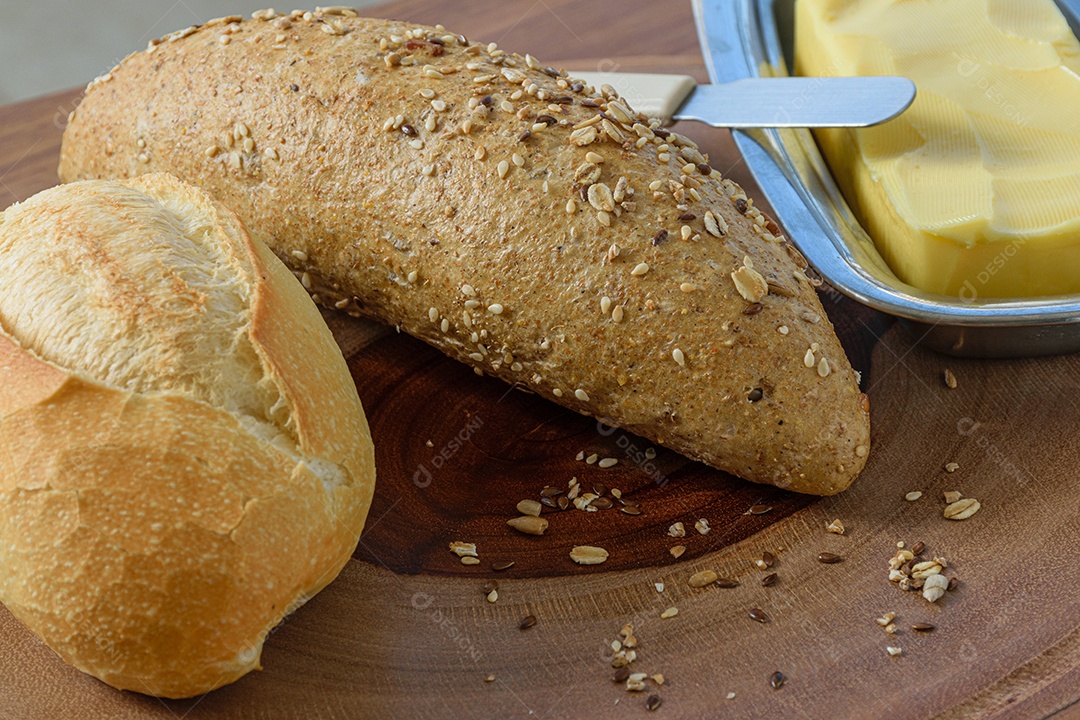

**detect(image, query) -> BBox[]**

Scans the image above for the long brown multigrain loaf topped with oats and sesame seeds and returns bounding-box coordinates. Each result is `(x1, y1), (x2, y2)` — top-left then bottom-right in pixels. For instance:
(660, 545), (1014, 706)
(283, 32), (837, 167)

(59, 9), (869, 494)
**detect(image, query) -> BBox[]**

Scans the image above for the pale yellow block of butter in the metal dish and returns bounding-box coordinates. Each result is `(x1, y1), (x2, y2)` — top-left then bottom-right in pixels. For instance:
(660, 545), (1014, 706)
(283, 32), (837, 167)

(795, 0), (1080, 300)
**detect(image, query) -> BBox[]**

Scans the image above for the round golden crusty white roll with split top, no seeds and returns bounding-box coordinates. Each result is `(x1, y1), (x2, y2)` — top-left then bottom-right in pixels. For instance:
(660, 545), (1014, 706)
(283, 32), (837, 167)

(0, 175), (375, 697)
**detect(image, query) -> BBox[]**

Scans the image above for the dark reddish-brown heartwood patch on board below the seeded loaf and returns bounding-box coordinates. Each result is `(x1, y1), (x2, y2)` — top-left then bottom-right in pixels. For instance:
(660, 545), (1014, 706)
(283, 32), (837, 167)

(350, 336), (813, 578)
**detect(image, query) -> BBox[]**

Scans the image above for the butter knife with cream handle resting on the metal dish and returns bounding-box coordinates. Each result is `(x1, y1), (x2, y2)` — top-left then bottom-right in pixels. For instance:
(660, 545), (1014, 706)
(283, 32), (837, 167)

(569, 70), (915, 127)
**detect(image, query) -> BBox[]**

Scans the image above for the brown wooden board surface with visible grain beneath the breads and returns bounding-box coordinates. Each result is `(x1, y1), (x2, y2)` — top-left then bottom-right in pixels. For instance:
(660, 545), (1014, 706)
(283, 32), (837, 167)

(0, 0), (1080, 720)
